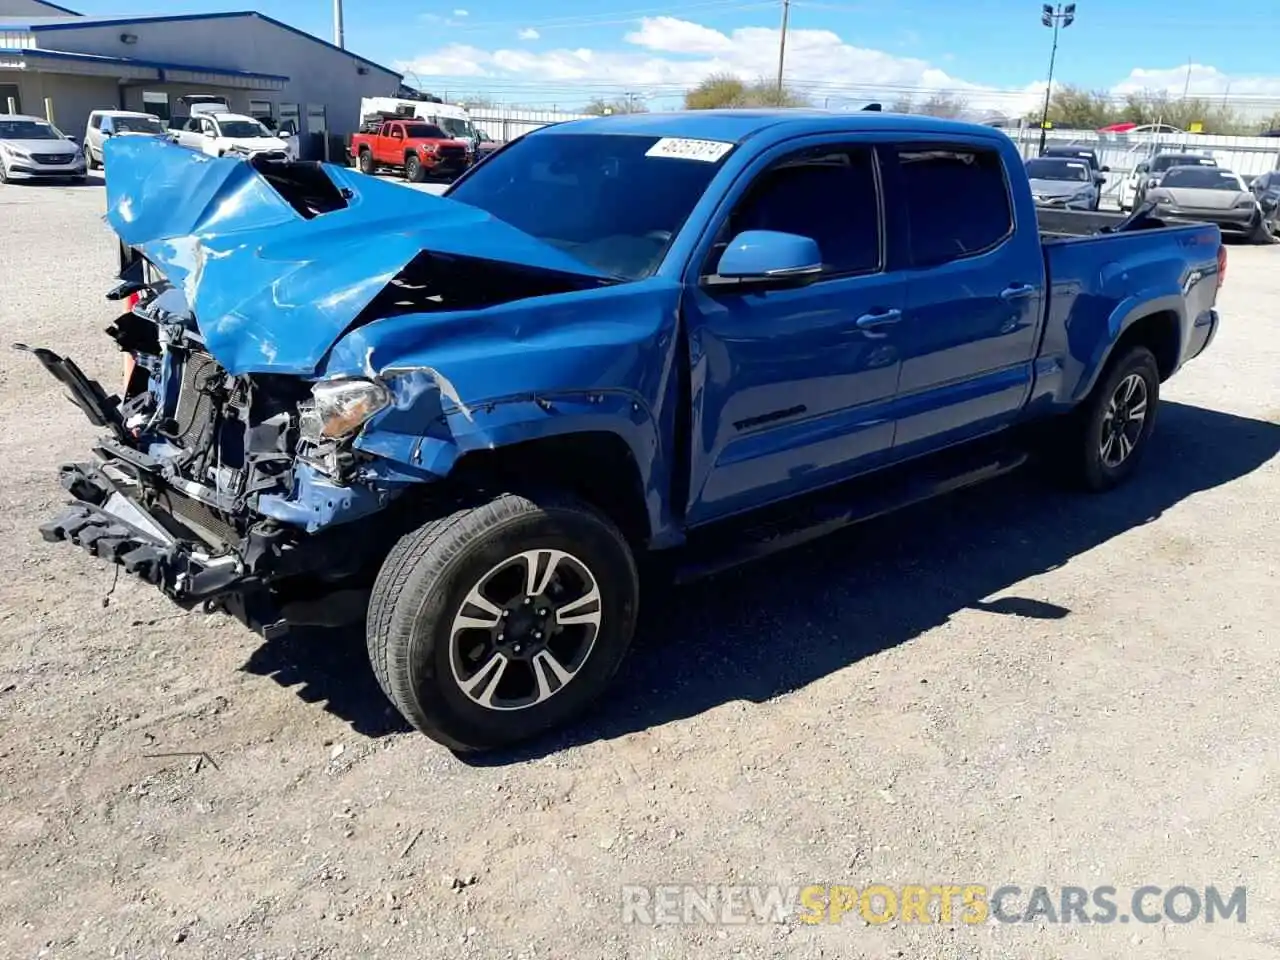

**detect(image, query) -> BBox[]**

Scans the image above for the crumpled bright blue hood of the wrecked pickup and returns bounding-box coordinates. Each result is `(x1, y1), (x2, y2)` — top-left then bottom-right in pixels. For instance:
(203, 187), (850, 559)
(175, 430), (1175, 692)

(104, 137), (608, 375)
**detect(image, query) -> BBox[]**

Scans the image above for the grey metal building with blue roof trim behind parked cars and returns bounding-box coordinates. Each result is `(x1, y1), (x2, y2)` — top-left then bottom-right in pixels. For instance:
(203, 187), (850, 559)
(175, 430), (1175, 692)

(0, 0), (401, 146)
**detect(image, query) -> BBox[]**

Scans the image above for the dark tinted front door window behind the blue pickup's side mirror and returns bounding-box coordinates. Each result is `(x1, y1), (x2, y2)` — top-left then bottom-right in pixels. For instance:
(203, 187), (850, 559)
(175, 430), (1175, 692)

(716, 147), (883, 275)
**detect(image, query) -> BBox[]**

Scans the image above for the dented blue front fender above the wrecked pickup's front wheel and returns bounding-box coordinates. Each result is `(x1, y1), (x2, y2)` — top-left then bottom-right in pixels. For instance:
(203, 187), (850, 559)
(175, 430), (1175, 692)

(321, 278), (681, 545)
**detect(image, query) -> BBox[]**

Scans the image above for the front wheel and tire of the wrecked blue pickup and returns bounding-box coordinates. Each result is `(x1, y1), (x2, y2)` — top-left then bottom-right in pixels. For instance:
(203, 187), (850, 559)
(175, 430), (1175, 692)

(367, 494), (640, 751)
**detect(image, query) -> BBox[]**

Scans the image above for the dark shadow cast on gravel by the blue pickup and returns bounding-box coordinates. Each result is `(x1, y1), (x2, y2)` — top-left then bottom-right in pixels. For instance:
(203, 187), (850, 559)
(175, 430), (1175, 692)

(235, 402), (1280, 765)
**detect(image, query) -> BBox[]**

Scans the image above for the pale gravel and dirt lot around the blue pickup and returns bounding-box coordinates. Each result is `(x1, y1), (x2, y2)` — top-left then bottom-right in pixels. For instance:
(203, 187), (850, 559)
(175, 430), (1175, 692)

(0, 175), (1280, 960)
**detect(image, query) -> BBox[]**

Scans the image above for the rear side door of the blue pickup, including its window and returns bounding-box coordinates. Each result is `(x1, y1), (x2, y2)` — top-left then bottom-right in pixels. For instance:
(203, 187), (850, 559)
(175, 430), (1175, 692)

(884, 137), (1044, 460)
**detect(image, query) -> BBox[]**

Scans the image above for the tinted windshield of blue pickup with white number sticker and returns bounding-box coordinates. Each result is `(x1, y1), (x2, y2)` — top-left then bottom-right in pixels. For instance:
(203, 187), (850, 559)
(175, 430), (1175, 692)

(445, 133), (732, 280)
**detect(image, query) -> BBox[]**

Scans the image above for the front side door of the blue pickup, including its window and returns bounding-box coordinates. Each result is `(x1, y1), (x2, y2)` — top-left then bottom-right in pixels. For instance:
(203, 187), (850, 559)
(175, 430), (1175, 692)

(684, 137), (904, 524)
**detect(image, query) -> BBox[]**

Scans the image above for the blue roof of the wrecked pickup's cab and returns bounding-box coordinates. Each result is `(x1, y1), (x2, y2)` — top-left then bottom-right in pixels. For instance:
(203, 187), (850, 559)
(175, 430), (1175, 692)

(536, 109), (1007, 143)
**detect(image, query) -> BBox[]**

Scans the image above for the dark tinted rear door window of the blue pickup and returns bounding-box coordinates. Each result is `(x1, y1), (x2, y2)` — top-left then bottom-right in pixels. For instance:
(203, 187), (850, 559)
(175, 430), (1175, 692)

(896, 145), (1014, 266)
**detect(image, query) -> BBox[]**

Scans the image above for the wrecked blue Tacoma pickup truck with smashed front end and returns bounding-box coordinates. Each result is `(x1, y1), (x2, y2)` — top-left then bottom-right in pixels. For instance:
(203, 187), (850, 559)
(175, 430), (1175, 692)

(27, 110), (1226, 750)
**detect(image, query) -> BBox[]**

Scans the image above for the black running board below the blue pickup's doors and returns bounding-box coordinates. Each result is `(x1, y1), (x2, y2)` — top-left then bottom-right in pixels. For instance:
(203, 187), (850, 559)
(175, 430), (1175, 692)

(675, 448), (1029, 584)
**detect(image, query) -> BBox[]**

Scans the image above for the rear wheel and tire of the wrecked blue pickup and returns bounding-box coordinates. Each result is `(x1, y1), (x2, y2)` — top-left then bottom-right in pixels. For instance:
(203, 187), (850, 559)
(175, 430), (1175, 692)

(1065, 347), (1160, 493)
